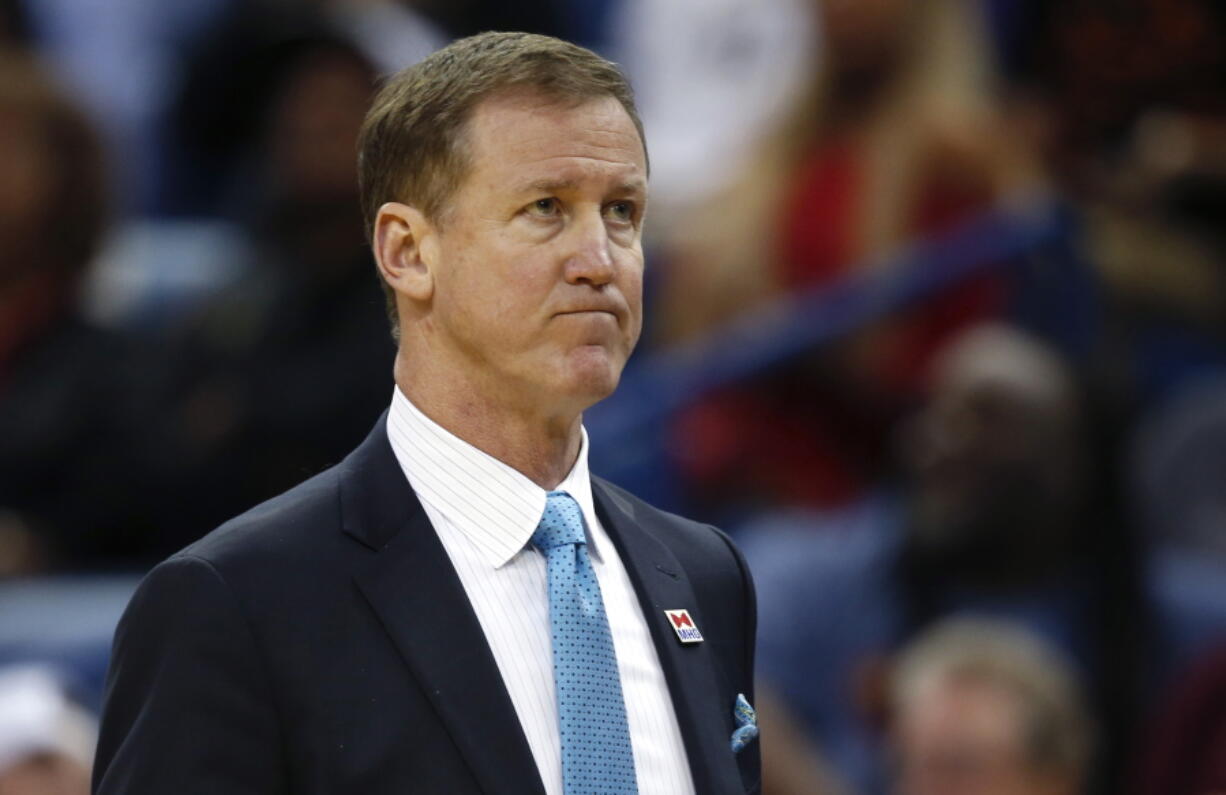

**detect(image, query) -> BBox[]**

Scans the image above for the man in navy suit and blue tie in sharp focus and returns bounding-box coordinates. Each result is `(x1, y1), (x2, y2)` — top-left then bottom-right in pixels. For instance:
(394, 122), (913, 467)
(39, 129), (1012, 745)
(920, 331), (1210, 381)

(94, 33), (759, 795)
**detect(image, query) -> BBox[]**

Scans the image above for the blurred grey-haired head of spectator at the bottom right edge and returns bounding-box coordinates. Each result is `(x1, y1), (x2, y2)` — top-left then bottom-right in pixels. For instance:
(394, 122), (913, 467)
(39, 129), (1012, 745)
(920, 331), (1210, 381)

(891, 620), (1092, 795)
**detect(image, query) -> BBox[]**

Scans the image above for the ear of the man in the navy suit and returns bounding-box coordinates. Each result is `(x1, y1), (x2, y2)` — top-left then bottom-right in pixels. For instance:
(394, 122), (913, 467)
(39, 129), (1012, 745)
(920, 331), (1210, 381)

(373, 201), (438, 302)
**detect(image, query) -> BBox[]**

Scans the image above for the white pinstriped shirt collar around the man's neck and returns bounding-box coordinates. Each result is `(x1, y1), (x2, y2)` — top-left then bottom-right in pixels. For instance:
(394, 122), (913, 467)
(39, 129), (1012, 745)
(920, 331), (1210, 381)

(387, 386), (600, 568)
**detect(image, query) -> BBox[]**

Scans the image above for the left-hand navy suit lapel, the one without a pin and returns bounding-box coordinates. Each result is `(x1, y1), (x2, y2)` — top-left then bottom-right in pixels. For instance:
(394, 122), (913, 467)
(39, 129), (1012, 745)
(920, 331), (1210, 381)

(341, 415), (544, 795)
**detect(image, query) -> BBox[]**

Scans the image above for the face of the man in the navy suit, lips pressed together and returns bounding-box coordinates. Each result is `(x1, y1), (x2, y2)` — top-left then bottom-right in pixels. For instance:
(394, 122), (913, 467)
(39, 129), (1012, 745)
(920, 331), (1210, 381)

(427, 93), (646, 413)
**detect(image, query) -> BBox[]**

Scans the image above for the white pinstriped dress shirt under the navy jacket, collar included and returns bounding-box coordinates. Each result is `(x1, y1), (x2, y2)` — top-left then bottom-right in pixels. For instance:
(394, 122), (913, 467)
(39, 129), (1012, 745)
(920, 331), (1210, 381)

(387, 388), (694, 795)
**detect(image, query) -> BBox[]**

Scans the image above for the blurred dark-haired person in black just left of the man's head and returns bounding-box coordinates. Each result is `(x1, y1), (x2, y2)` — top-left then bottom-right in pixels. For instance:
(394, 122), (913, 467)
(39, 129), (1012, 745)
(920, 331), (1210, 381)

(140, 20), (395, 553)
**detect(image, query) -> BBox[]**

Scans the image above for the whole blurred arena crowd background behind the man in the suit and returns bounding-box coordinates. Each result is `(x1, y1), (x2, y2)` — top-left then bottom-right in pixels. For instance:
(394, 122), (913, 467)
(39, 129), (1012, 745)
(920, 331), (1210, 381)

(0, 0), (1226, 795)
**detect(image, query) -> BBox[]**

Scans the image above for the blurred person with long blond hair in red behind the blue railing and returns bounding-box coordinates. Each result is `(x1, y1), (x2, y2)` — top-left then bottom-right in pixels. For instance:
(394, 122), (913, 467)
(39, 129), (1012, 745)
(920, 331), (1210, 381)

(776, 0), (1037, 393)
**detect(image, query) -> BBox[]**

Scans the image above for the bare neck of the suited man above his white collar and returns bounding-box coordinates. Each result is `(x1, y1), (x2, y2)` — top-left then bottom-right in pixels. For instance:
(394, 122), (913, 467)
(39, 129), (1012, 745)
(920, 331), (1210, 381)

(395, 348), (582, 490)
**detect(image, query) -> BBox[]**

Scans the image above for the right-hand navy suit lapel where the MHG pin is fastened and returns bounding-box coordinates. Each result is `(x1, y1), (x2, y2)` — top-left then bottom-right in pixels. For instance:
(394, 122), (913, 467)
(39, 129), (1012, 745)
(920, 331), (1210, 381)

(592, 478), (744, 794)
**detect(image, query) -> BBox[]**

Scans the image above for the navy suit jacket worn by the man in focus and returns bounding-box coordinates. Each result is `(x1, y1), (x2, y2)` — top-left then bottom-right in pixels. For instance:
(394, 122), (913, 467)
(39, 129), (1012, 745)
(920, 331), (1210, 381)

(93, 416), (760, 795)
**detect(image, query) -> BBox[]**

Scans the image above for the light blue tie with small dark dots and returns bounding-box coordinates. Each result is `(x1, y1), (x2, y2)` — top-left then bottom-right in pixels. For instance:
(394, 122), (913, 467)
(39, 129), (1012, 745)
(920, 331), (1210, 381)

(532, 492), (639, 795)
